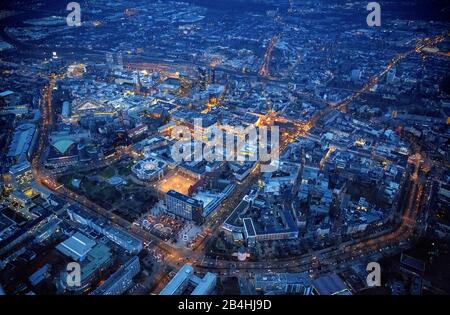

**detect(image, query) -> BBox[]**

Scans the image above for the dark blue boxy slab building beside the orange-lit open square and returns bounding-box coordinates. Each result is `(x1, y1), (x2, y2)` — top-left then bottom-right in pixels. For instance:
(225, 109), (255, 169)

(166, 190), (203, 224)
